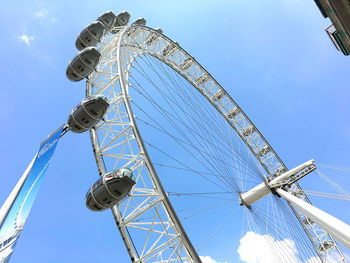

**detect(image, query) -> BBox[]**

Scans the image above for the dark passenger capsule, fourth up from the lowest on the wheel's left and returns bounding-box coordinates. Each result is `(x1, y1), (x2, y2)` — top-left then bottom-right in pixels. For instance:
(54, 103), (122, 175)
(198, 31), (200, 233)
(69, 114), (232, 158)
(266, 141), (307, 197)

(75, 21), (106, 50)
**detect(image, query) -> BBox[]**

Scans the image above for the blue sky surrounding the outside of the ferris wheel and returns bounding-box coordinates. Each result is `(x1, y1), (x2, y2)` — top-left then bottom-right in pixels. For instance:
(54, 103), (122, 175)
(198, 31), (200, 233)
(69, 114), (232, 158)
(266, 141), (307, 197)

(0, 0), (350, 262)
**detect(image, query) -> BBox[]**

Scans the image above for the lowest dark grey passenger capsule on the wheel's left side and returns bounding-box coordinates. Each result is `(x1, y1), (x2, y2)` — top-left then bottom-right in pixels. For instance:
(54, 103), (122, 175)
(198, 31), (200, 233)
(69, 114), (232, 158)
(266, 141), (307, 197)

(85, 168), (136, 211)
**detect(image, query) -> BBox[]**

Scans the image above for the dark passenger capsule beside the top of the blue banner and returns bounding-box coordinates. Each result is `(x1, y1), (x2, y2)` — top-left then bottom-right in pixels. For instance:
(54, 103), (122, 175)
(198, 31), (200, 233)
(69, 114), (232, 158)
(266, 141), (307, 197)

(68, 95), (109, 133)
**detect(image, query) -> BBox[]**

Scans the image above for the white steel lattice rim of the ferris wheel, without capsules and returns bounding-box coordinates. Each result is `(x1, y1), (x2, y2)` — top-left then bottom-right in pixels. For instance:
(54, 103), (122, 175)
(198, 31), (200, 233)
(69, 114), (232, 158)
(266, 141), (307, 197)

(86, 25), (346, 262)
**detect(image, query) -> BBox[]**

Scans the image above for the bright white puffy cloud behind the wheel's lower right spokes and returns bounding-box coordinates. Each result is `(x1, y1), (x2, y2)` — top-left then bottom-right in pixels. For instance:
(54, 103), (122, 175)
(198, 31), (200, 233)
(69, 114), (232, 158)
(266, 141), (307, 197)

(237, 231), (321, 263)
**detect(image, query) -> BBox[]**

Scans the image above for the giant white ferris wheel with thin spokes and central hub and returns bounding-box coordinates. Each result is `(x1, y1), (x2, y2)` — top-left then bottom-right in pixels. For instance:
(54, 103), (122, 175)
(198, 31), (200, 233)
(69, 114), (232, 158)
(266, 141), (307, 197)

(67, 9), (347, 262)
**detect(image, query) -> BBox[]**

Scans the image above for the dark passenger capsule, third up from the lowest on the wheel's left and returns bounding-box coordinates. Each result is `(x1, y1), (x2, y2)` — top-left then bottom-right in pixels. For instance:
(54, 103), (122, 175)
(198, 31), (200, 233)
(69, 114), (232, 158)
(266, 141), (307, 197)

(66, 47), (101, 81)
